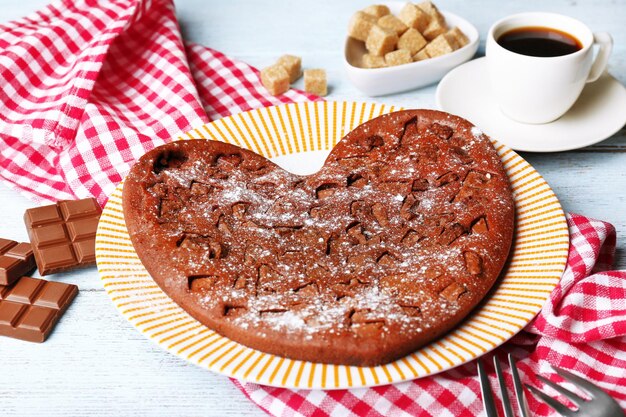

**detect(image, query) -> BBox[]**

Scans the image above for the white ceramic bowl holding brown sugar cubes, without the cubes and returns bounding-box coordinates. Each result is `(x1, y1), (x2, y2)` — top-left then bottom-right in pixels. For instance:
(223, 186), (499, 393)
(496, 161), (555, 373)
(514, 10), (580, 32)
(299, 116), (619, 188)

(344, 1), (479, 96)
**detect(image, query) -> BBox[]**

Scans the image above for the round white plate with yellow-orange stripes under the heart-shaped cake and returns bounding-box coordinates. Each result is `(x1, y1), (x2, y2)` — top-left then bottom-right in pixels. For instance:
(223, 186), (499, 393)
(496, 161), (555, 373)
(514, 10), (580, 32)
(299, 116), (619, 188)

(96, 102), (569, 389)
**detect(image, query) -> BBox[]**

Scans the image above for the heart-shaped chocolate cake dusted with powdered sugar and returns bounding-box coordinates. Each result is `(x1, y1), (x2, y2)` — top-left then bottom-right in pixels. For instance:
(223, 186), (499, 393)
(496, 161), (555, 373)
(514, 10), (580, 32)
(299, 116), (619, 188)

(123, 110), (514, 366)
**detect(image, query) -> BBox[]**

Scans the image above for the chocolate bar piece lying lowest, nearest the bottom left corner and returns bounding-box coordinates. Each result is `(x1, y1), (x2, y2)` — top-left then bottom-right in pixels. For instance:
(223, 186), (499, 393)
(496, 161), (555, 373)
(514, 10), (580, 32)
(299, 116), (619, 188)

(0, 277), (78, 343)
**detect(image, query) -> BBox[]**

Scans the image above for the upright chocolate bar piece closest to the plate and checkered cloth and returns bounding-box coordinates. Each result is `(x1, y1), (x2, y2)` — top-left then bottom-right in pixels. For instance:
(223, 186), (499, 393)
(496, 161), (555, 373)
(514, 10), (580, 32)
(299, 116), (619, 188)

(24, 198), (102, 275)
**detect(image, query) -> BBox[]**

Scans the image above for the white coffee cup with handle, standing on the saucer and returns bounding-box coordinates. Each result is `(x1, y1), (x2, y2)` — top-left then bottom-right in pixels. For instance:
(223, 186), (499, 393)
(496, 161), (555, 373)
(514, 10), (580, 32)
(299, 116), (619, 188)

(486, 12), (613, 123)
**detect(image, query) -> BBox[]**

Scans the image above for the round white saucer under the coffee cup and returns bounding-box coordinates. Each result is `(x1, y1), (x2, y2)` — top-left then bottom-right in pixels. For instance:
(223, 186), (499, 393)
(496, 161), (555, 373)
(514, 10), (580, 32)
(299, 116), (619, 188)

(436, 57), (626, 152)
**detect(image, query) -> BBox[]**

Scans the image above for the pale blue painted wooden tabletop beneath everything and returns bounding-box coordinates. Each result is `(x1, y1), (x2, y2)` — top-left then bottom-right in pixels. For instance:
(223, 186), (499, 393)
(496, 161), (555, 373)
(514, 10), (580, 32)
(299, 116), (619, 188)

(0, 0), (626, 417)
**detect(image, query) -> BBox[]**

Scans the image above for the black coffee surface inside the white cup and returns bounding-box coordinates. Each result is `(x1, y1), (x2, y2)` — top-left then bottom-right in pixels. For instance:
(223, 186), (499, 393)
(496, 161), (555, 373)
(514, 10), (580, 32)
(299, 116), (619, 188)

(497, 26), (583, 57)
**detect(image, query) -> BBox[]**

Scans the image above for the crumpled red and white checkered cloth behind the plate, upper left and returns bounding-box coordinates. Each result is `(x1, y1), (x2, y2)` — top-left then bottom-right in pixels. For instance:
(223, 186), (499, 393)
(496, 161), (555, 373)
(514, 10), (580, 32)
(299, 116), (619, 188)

(0, 0), (317, 204)
